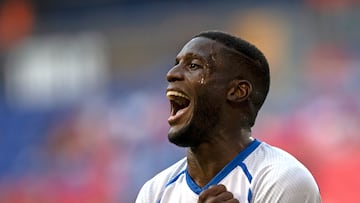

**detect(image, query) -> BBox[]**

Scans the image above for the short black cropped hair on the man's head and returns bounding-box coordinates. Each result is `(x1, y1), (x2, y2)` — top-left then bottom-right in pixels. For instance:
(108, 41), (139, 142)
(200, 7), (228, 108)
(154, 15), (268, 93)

(193, 30), (270, 126)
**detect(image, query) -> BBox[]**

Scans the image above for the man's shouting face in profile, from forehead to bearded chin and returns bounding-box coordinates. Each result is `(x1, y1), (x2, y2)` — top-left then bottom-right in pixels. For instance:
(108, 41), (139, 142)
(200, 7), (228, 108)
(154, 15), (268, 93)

(166, 37), (226, 147)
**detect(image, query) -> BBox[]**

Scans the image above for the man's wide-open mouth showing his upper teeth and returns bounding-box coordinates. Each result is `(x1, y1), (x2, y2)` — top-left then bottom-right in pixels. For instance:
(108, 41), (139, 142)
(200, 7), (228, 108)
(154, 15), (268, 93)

(166, 90), (190, 120)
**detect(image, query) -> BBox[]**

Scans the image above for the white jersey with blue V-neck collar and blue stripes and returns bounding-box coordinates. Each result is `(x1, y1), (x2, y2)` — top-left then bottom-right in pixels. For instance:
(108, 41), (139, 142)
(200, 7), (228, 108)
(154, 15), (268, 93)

(136, 140), (321, 203)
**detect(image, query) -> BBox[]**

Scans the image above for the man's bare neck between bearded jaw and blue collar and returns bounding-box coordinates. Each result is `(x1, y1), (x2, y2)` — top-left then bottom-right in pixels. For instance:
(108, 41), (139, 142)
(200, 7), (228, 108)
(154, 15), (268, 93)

(187, 129), (254, 187)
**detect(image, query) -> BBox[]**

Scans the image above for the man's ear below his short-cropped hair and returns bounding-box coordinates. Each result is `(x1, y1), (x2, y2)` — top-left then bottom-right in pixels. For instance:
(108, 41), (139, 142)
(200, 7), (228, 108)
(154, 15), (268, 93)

(226, 80), (252, 102)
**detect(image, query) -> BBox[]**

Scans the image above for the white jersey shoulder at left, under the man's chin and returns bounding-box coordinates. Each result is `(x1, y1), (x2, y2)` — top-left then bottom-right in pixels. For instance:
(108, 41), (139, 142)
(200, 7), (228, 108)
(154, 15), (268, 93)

(136, 158), (187, 203)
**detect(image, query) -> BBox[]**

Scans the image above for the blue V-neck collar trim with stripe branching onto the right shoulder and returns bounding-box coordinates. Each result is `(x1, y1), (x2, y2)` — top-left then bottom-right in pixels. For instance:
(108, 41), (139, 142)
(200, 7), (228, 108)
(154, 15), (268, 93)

(185, 140), (261, 195)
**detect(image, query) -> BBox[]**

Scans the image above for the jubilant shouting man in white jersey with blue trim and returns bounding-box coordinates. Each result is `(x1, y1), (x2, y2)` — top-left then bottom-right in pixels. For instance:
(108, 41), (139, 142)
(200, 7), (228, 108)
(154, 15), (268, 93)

(136, 31), (321, 203)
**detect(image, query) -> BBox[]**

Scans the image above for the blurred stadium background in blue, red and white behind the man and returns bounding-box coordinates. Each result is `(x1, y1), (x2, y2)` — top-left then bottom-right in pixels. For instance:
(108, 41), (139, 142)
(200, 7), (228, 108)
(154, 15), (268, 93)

(0, 0), (360, 203)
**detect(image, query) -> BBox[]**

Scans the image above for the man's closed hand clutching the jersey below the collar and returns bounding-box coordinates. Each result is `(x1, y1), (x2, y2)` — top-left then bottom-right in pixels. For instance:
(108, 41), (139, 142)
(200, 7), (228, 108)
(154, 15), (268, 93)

(198, 184), (239, 203)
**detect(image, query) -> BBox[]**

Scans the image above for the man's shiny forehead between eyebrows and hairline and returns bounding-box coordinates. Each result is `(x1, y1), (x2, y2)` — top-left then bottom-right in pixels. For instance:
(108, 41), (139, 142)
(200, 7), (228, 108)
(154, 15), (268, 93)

(177, 37), (225, 58)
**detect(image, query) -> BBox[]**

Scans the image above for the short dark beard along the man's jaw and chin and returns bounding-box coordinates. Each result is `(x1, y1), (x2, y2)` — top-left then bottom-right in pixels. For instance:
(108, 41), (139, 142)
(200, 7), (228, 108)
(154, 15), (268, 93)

(168, 93), (220, 147)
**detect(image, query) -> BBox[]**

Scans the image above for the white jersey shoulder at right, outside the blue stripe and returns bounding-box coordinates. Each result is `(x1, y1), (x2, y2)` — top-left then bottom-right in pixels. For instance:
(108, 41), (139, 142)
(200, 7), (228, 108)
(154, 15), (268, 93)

(248, 143), (321, 202)
